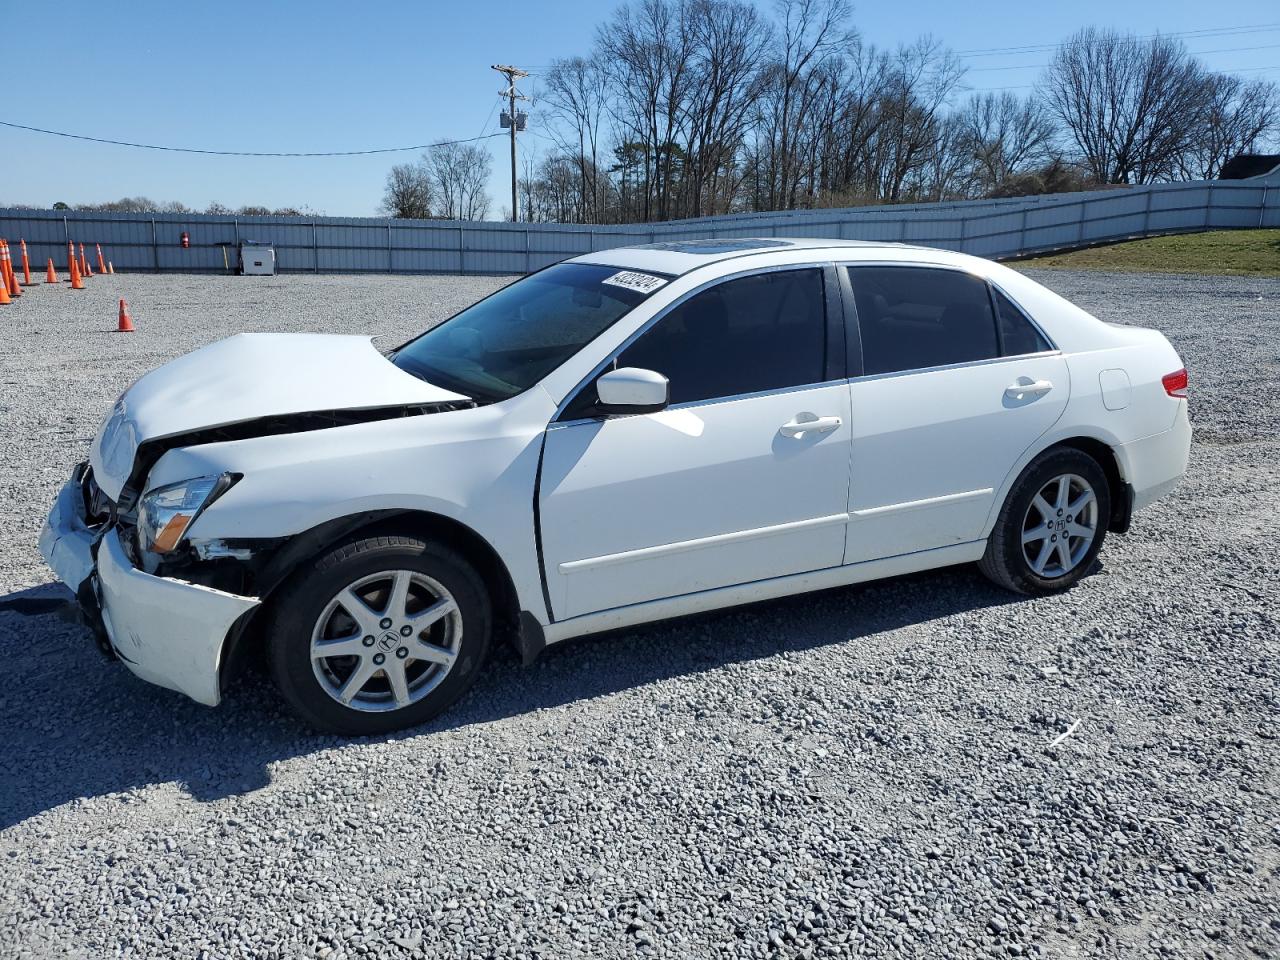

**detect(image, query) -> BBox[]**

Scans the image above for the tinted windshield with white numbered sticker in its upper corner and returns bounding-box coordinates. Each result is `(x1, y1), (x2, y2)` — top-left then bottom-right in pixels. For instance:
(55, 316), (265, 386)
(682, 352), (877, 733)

(392, 264), (668, 401)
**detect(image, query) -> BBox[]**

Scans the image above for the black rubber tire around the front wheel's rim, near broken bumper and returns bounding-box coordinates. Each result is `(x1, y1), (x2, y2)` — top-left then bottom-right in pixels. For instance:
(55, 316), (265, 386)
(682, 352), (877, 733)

(268, 536), (493, 736)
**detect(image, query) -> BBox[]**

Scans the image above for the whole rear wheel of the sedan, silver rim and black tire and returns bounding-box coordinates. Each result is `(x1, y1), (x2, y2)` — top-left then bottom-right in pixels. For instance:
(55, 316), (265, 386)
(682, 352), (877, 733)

(978, 447), (1111, 594)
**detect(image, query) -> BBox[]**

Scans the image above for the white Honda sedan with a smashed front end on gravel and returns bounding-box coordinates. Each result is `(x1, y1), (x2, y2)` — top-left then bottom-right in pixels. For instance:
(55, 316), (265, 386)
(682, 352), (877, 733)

(41, 239), (1190, 733)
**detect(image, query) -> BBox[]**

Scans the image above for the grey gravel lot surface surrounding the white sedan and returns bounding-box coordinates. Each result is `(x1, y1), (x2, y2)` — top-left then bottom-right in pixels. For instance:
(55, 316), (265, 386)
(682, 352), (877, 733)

(0, 264), (1280, 960)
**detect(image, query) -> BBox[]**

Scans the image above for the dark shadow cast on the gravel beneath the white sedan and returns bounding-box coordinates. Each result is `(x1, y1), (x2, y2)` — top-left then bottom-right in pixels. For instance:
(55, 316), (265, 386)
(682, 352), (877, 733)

(0, 567), (1019, 828)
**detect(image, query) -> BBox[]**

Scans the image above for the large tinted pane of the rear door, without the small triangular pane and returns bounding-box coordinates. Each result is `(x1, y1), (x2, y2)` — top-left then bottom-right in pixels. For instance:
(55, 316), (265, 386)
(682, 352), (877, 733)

(846, 266), (1000, 374)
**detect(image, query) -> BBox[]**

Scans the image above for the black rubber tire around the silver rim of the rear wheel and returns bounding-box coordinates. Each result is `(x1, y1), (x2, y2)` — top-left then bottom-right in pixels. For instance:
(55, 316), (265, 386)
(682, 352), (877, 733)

(978, 447), (1111, 596)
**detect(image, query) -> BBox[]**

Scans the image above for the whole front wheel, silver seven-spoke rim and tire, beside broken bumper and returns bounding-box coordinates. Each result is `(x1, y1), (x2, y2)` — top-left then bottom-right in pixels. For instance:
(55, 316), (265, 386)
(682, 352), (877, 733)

(270, 536), (492, 735)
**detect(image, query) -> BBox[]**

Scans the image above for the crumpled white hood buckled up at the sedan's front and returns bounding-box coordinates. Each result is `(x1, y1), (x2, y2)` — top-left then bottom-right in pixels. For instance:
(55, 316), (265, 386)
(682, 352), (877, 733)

(90, 333), (465, 499)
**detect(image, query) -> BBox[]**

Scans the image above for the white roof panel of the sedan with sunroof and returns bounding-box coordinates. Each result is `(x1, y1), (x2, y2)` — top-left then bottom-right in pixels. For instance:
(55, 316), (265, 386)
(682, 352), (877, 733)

(571, 237), (960, 276)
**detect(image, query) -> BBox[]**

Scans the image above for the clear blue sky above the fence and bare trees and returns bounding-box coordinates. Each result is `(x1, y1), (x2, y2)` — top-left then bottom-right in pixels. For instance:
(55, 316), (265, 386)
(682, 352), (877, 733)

(0, 0), (1280, 216)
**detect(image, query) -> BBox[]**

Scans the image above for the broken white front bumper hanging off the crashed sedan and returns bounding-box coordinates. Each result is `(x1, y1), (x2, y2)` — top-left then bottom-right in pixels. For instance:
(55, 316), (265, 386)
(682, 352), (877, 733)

(40, 466), (261, 707)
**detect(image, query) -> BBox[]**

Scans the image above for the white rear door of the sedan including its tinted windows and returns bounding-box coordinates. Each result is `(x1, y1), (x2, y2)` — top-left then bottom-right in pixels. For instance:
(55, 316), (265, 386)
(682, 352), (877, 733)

(842, 266), (1070, 563)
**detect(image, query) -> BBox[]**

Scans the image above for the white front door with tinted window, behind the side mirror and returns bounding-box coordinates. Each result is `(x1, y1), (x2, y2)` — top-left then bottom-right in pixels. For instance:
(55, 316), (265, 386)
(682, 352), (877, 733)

(539, 268), (850, 620)
